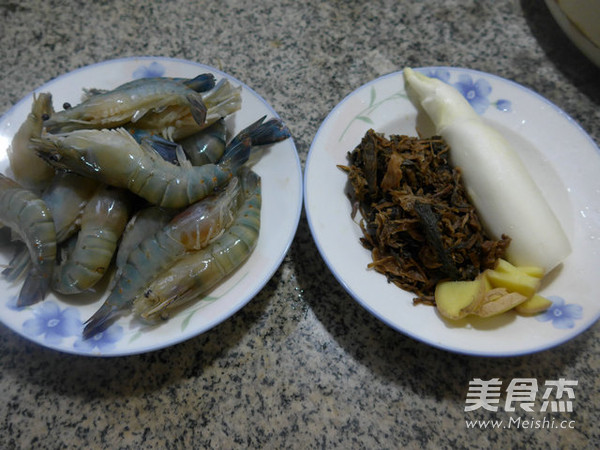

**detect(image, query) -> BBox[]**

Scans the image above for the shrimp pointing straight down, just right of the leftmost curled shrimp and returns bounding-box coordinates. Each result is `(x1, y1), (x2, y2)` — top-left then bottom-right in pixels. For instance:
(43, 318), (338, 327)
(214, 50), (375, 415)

(52, 186), (131, 294)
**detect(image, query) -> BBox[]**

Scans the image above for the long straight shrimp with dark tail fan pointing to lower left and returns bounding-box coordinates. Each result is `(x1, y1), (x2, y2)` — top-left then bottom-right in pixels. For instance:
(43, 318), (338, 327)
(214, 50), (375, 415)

(83, 177), (241, 338)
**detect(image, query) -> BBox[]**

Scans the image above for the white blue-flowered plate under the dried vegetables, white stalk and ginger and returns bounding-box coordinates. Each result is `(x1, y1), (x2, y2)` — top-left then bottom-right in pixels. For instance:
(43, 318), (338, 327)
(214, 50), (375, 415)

(304, 67), (600, 356)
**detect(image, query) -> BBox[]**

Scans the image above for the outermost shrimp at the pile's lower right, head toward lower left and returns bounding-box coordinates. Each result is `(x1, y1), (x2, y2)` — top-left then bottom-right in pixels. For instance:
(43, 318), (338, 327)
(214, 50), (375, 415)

(134, 171), (261, 320)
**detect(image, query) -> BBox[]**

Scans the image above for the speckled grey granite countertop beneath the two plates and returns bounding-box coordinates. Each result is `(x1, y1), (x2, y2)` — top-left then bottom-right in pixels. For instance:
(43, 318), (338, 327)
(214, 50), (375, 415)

(0, 0), (600, 449)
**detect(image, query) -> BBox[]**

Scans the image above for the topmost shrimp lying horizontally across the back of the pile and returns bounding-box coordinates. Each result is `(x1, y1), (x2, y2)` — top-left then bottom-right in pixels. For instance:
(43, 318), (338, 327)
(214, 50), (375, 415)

(44, 74), (207, 133)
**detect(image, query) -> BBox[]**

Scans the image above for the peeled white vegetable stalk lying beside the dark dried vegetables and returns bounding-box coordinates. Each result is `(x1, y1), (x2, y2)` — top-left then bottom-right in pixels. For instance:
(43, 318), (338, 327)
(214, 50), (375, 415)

(404, 68), (571, 273)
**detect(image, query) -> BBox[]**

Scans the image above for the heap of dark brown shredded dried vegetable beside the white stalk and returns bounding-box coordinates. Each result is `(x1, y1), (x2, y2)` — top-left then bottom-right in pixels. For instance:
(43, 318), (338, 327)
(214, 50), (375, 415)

(339, 130), (510, 304)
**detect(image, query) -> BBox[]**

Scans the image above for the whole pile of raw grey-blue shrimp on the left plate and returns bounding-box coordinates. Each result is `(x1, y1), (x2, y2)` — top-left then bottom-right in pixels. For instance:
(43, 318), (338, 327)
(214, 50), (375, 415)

(0, 74), (290, 338)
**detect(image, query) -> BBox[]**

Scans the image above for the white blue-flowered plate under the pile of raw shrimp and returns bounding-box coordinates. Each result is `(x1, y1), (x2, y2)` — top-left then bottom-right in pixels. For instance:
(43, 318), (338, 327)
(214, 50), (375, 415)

(0, 57), (302, 356)
